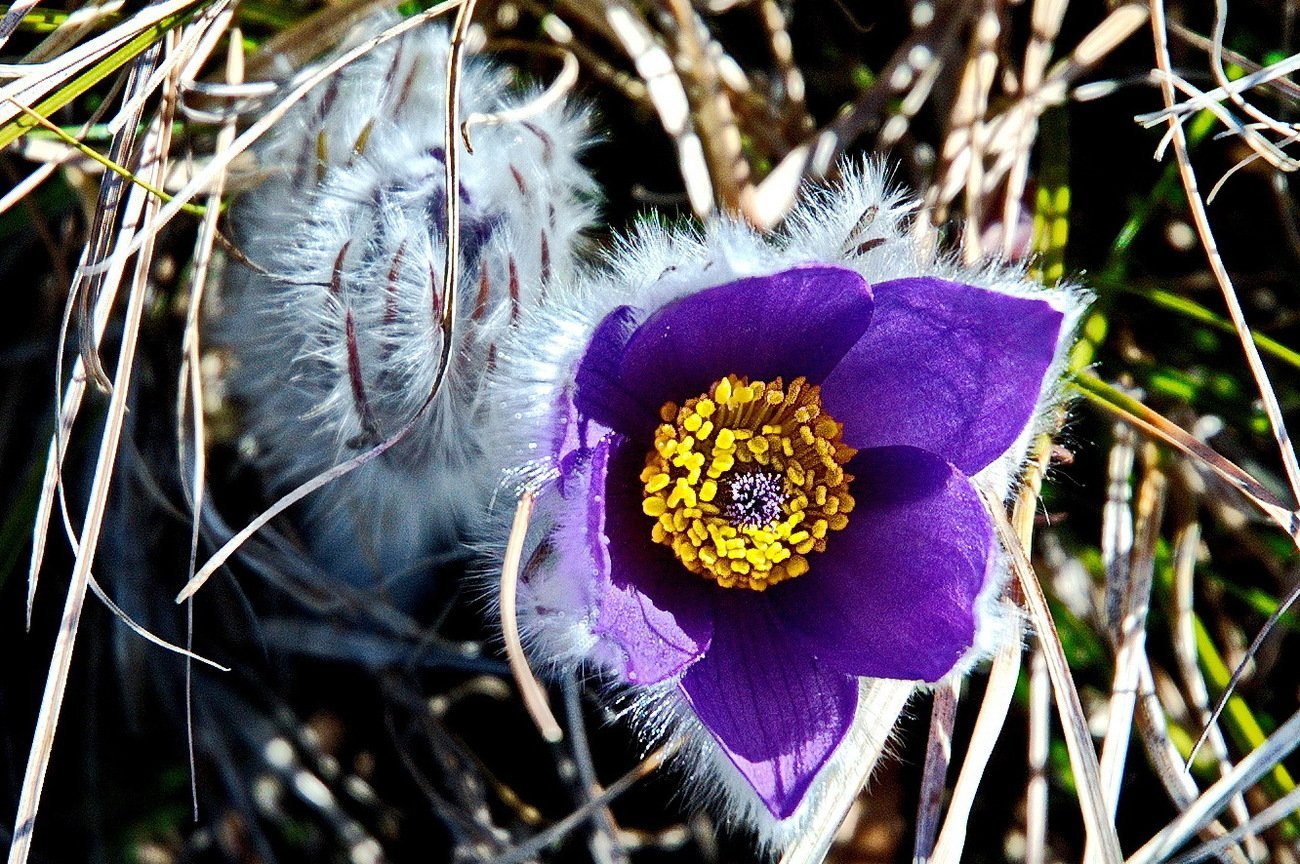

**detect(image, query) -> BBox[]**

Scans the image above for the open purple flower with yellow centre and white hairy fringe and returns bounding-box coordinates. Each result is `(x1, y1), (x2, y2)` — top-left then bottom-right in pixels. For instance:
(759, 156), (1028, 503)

(488, 163), (1079, 838)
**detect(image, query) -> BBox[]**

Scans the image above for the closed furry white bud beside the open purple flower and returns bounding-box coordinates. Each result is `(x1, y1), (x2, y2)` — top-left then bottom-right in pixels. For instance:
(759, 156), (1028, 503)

(217, 18), (594, 597)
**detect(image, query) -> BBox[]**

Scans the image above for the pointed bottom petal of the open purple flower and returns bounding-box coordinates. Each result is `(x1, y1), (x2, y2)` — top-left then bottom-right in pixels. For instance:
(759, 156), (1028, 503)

(681, 589), (858, 819)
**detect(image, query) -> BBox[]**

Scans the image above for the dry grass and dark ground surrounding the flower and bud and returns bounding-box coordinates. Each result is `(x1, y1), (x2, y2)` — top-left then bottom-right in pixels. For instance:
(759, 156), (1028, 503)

(0, 0), (1300, 864)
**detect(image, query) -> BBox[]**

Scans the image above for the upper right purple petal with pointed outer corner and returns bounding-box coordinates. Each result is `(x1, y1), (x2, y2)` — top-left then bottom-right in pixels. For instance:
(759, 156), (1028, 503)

(822, 277), (1063, 474)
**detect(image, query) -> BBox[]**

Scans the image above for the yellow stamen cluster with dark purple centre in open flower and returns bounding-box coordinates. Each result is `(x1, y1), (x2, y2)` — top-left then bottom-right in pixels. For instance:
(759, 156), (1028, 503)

(641, 375), (857, 591)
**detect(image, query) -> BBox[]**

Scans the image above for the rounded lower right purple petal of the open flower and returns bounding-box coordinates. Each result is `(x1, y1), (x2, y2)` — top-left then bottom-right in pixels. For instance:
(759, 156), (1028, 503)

(771, 447), (993, 681)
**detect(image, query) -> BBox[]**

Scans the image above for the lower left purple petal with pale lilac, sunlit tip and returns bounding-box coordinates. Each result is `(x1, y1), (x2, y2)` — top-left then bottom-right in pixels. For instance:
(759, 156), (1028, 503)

(585, 437), (714, 685)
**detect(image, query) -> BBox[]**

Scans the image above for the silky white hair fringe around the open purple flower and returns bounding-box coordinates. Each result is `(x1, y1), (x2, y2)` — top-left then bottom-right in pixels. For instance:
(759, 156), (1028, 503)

(489, 162), (1088, 852)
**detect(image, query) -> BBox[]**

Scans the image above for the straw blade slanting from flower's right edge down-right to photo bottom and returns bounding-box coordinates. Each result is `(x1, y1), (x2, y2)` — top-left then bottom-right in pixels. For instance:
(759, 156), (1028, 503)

(975, 483), (1123, 864)
